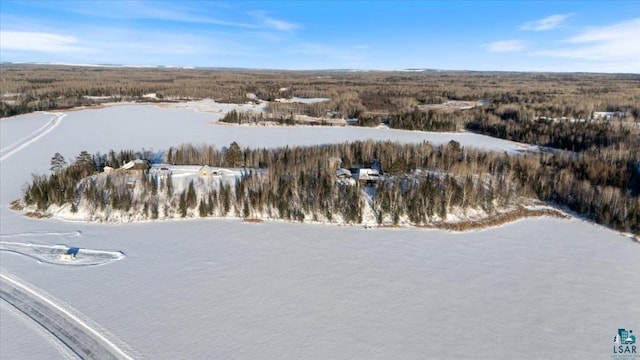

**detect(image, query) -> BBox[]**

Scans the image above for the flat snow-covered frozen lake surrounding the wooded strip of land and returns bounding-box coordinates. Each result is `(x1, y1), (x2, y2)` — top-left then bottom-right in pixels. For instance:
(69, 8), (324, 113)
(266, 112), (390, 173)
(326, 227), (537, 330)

(0, 101), (640, 359)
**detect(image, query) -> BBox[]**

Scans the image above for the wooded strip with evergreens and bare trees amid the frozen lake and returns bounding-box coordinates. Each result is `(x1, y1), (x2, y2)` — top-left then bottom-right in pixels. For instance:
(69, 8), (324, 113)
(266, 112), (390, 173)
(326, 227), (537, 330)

(17, 141), (640, 233)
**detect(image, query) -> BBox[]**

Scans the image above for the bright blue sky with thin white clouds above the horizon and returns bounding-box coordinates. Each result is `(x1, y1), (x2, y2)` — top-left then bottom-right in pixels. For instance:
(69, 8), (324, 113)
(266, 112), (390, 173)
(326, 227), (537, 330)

(0, 0), (640, 73)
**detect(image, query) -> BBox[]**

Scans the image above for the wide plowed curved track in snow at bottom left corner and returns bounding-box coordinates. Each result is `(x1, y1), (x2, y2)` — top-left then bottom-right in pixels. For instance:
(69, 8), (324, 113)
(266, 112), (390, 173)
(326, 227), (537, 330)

(0, 272), (141, 360)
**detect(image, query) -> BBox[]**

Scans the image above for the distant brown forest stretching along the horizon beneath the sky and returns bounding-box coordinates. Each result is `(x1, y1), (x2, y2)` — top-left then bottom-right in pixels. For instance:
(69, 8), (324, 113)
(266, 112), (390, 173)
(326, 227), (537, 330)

(0, 63), (640, 122)
